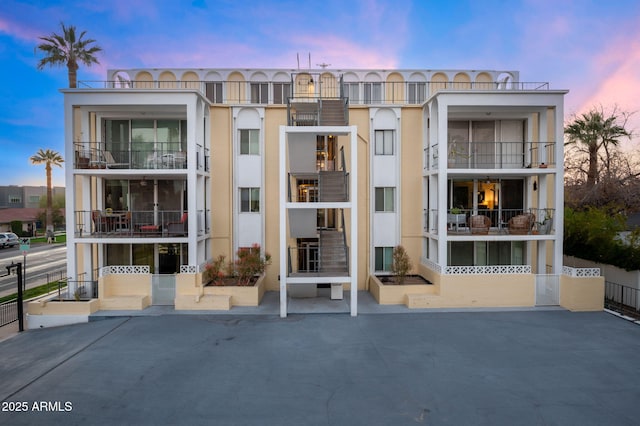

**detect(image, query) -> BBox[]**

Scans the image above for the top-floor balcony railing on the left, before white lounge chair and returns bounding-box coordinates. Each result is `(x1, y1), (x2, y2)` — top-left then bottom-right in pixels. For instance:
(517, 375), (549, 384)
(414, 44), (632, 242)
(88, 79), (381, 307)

(74, 142), (189, 170)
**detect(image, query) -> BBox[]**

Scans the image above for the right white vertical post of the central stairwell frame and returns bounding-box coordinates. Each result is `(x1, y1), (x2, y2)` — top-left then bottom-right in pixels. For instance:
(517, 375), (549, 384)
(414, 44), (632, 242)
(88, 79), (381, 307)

(349, 126), (358, 317)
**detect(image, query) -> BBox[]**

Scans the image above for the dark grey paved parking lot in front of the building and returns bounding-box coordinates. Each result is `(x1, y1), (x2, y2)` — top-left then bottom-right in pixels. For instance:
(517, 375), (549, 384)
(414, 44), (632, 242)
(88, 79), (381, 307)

(0, 296), (640, 425)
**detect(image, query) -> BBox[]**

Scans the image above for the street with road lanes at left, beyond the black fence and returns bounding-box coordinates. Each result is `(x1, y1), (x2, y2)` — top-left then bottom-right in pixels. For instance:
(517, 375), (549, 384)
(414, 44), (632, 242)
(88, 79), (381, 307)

(0, 244), (67, 296)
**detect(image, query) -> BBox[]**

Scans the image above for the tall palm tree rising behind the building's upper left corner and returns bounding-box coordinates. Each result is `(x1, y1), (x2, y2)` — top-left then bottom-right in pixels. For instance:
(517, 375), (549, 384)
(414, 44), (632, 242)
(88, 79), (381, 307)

(38, 23), (102, 88)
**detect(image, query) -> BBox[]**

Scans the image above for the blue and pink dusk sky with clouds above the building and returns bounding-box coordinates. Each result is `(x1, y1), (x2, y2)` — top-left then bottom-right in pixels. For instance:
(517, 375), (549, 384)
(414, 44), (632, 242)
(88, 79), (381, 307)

(0, 0), (640, 185)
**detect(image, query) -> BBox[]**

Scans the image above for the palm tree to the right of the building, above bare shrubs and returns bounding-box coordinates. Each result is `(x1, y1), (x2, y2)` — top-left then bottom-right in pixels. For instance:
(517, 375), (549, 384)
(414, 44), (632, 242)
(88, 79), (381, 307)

(564, 108), (631, 187)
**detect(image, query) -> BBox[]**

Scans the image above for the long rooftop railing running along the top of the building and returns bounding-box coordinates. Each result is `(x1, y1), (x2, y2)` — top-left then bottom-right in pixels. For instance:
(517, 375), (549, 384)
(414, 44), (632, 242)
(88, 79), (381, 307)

(78, 80), (550, 105)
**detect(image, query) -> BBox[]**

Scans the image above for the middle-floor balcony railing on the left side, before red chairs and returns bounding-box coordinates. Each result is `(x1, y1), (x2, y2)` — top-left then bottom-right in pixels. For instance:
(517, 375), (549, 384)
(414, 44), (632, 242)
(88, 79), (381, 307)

(74, 209), (192, 238)
